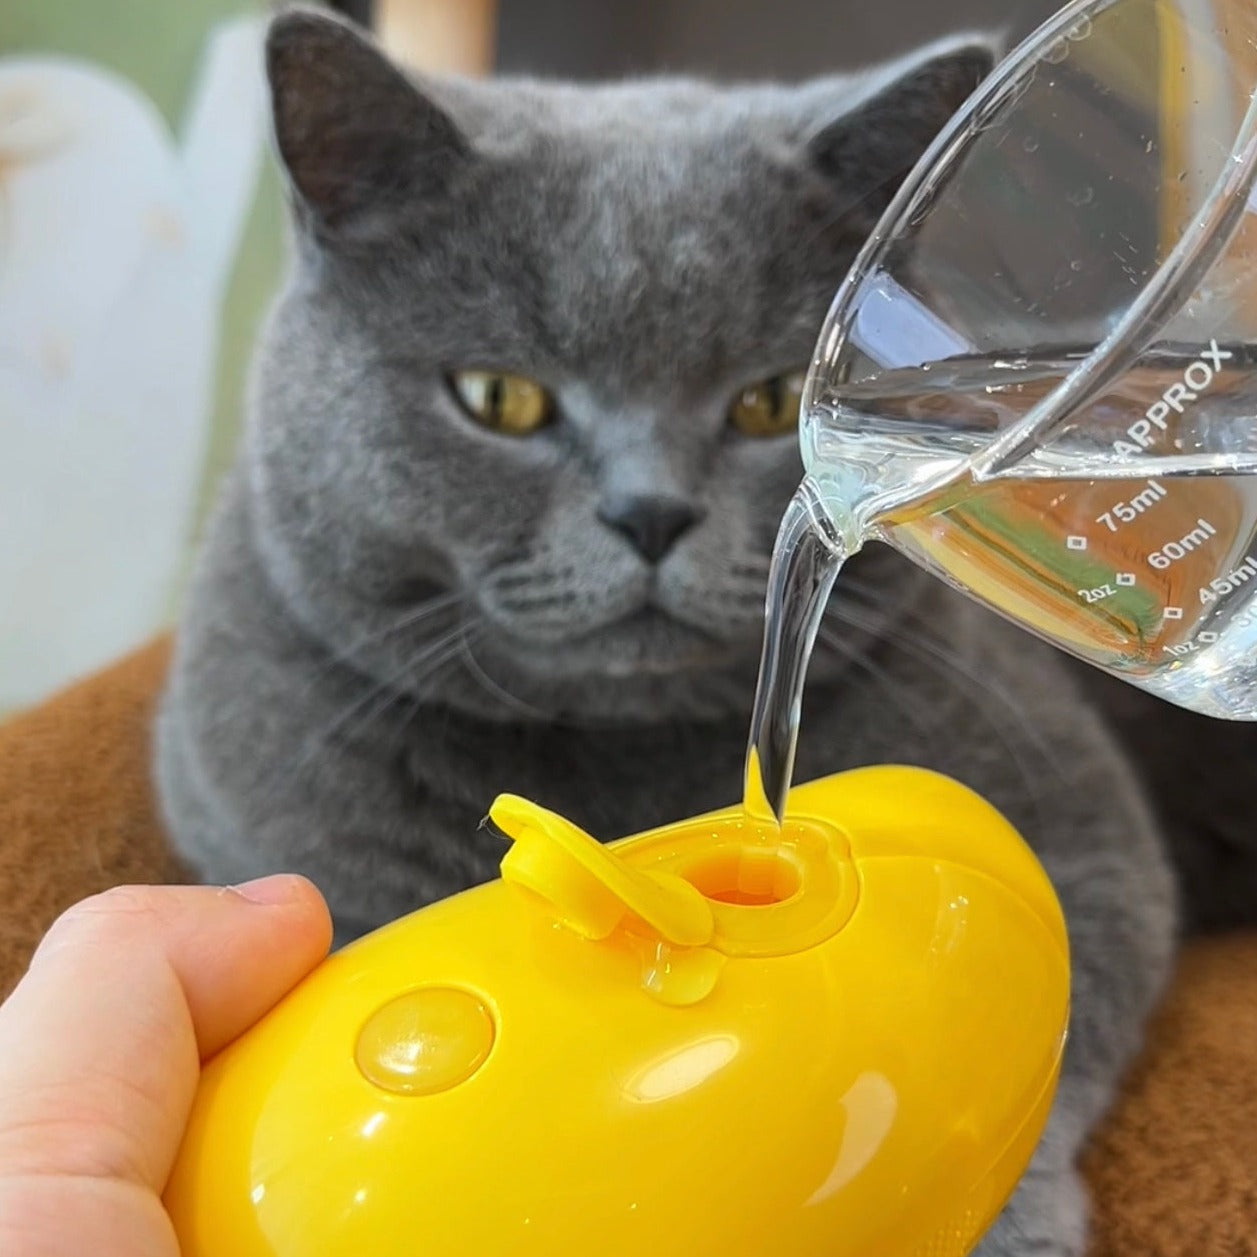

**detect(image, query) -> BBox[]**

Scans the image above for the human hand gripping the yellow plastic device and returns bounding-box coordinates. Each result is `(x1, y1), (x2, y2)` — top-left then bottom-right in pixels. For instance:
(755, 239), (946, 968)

(0, 876), (332, 1257)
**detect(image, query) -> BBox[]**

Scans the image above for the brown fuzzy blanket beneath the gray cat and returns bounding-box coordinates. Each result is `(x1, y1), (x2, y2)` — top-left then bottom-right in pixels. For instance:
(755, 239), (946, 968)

(0, 641), (1257, 1257)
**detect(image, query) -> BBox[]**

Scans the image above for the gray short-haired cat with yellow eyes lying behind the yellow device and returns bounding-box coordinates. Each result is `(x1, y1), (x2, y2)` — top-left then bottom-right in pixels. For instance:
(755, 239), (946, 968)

(157, 11), (1174, 1254)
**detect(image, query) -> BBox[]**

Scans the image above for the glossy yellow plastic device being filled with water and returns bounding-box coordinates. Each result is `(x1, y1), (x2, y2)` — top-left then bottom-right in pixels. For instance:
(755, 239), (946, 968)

(166, 768), (1068, 1257)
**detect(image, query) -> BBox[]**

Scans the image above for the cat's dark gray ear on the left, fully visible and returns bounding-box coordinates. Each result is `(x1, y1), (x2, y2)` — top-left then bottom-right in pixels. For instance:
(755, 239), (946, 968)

(266, 8), (470, 239)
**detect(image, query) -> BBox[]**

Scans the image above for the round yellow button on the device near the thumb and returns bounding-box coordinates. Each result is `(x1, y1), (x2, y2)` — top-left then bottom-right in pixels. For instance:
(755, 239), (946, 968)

(353, 987), (494, 1096)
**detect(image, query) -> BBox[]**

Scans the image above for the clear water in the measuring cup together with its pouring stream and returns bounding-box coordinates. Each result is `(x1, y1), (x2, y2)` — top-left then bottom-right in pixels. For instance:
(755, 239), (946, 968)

(747, 346), (1257, 816)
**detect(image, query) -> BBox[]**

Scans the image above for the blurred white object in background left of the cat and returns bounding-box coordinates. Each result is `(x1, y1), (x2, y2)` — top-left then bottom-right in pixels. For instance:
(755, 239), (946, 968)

(0, 19), (266, 710)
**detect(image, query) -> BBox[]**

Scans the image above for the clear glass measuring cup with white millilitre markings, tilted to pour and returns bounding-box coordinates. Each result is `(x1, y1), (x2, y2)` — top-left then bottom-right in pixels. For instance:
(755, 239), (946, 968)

(801, 0), (1257, 720)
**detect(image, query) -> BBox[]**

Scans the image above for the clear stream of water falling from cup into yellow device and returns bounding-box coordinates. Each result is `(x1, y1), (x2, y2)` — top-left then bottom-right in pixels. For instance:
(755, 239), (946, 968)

(743, 480), (848, 828)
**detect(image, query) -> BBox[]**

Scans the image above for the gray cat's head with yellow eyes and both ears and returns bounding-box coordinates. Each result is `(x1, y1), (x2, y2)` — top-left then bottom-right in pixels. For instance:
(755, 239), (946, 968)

(250, 13), (988, 716)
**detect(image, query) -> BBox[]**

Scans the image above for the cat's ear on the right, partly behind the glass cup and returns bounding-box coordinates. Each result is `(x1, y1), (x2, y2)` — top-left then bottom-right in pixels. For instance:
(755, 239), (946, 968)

(807, 36), (999, 214)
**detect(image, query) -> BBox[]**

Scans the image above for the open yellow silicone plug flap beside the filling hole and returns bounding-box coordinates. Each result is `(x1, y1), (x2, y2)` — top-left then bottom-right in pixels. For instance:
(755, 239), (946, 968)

(489, 794), (715, 947)
